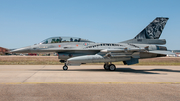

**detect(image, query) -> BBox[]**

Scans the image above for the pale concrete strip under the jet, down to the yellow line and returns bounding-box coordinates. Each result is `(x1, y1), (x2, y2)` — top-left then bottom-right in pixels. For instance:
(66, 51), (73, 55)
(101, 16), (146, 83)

(0, 65), (180, 83)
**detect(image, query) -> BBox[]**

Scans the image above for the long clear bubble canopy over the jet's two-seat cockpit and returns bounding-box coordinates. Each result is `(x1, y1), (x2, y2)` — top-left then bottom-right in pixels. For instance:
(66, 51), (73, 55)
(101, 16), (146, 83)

(39, 37), (92, 44)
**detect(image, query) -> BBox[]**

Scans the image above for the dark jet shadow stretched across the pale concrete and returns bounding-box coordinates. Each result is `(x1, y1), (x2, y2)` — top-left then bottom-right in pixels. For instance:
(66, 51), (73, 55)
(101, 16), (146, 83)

(29, 68), (180, 74)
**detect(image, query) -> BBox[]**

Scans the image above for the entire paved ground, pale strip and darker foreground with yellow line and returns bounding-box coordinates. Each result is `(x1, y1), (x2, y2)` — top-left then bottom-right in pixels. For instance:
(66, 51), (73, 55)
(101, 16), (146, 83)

(0, 65), (180, 101)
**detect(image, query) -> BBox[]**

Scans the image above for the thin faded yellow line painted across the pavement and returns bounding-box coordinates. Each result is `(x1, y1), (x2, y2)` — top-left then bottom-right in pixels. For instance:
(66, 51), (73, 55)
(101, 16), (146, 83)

(0, 82), (180, 85)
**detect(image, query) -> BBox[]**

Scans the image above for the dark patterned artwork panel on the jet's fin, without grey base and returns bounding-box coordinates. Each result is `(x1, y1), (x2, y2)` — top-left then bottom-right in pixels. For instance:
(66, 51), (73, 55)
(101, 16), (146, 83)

(134, 17), (169, 39)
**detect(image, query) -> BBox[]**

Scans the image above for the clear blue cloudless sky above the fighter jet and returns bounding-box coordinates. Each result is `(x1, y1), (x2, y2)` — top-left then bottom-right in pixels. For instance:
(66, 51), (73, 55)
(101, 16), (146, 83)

(0, 0), (180, 50)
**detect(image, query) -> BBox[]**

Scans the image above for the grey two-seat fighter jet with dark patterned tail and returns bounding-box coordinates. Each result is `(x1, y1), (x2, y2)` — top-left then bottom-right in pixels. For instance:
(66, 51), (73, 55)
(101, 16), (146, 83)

(11, 17), (174, 71)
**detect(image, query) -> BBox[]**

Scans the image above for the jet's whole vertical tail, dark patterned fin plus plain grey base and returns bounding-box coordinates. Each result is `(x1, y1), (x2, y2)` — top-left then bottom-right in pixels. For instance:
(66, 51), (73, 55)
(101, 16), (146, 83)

(121, 17), (169, 45)
